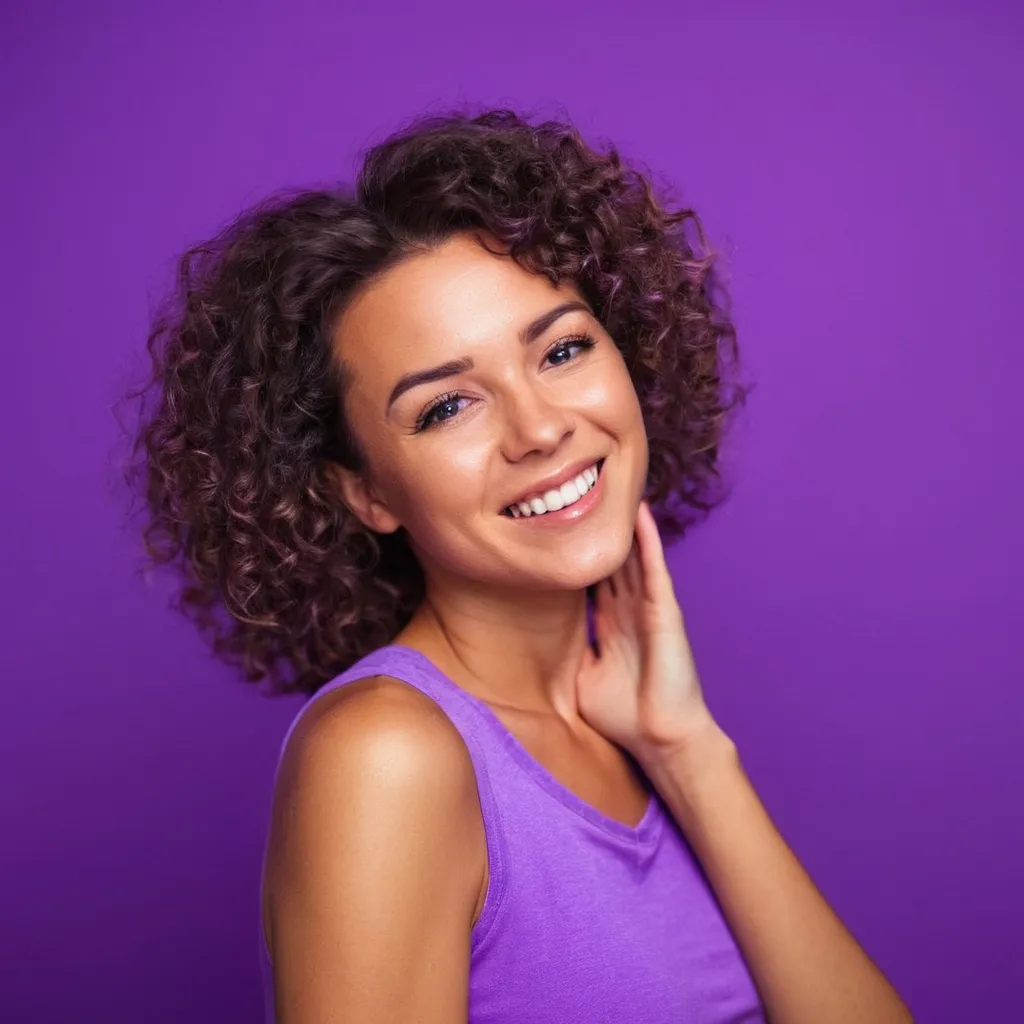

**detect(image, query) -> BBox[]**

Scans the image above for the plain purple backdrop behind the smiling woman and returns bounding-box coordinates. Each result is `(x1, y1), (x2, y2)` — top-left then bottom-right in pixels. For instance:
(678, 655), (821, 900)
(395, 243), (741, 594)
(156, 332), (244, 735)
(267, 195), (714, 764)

(0, 0), (1024, 1024)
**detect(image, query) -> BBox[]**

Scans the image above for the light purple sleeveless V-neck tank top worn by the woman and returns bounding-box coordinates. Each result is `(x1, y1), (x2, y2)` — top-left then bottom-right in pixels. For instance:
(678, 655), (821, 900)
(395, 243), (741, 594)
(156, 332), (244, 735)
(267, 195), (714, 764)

(262, 645), (765, 1024)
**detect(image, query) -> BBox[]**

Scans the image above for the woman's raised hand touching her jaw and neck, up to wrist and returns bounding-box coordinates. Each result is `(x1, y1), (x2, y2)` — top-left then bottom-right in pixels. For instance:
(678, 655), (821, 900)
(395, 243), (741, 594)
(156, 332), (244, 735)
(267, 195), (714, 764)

(577, 502), (718, 765)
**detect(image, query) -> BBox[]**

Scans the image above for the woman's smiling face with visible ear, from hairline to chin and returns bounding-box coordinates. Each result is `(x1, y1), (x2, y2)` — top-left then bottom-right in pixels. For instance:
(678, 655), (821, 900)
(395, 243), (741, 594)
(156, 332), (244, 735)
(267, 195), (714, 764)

(335, 228), (647, 590)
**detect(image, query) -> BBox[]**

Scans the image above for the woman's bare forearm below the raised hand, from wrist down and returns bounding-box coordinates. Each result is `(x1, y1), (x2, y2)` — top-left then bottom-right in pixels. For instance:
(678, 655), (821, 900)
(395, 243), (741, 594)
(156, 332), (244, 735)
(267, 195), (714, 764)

(644, 725), (912, 1024)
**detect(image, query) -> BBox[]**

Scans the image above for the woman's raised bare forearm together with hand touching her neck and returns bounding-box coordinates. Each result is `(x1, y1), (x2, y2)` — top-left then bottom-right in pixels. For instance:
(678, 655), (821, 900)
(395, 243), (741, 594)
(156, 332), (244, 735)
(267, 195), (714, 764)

(577, 503), (911, 1024)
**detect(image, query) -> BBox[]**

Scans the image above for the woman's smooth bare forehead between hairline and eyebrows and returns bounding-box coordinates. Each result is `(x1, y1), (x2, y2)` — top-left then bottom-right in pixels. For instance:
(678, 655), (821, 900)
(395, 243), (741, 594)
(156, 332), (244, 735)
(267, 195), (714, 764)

(334, 236), (580, 388)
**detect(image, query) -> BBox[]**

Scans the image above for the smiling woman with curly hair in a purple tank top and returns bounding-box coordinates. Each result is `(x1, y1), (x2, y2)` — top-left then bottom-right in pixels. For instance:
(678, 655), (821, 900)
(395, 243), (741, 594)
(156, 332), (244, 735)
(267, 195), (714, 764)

(130, 111), (910, 1024)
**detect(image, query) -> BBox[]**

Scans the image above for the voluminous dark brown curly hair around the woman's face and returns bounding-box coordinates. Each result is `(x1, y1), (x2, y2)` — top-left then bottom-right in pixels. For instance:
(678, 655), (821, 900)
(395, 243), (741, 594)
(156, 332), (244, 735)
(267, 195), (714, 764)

(127, 110), (750, 693)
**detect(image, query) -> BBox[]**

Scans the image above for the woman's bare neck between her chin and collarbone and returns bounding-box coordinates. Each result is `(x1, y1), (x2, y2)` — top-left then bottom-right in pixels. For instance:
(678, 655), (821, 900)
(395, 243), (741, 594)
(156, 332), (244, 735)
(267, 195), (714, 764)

(395, 580), (587, 722)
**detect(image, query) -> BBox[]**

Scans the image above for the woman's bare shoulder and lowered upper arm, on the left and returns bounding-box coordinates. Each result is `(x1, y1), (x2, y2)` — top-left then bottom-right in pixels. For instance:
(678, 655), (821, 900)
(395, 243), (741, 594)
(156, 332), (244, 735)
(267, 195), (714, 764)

(263, 676), (485, 1021)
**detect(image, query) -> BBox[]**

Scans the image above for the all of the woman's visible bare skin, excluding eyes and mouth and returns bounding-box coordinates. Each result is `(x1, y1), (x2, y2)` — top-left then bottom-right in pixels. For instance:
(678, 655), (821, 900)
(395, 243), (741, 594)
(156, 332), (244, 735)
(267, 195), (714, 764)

(264, 236), (910, 1024)
